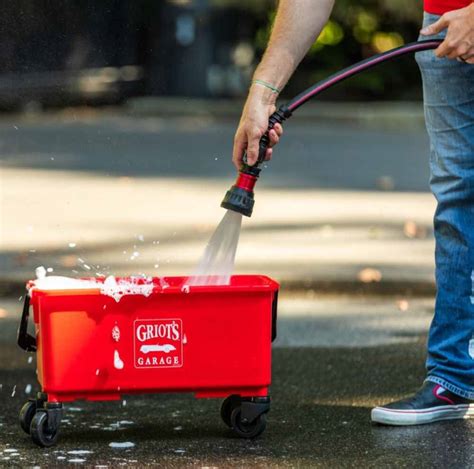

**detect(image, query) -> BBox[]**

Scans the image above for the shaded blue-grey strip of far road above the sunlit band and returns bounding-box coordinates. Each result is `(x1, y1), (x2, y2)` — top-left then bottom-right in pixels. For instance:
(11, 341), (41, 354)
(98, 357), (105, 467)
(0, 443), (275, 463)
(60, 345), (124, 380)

(0, 113), (428, 191)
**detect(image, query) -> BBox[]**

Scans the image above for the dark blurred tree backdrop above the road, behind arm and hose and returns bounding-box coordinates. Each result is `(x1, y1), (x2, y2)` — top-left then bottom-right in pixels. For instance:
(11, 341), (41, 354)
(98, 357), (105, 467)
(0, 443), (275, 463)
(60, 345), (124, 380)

(0, 0), (422, 108)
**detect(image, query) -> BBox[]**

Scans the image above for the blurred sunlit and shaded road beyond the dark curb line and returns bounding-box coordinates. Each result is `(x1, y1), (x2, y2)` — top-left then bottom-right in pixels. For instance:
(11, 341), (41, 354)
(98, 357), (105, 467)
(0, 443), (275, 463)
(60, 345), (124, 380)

(0, 109), (435, 294)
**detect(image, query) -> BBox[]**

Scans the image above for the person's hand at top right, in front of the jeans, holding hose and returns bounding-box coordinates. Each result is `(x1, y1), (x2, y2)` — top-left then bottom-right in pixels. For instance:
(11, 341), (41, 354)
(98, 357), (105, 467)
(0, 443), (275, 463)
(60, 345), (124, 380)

(420, 3), (474, 64)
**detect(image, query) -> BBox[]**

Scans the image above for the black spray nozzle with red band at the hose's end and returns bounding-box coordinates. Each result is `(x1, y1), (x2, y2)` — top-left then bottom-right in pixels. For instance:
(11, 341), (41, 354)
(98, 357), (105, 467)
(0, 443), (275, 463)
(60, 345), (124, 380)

(221, 106), (291, 217)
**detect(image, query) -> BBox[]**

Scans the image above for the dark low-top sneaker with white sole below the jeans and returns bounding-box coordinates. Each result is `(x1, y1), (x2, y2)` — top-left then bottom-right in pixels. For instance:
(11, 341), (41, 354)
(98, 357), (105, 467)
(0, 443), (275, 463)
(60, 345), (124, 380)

(371, 381), (474, 425)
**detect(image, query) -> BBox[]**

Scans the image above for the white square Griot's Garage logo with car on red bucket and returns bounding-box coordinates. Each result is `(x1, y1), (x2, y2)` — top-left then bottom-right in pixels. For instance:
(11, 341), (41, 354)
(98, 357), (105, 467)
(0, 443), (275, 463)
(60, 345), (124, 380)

(134, 319), (183, 368)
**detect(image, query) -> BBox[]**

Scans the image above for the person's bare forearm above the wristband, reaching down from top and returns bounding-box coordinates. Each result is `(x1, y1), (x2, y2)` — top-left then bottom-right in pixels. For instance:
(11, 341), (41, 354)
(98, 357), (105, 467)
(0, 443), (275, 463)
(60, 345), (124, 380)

(254, 0), (334, 94)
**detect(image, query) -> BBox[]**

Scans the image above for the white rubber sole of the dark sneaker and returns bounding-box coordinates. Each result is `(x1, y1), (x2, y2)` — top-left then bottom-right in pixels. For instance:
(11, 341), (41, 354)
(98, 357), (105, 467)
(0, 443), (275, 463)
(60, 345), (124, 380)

(371, 404), (474, 425)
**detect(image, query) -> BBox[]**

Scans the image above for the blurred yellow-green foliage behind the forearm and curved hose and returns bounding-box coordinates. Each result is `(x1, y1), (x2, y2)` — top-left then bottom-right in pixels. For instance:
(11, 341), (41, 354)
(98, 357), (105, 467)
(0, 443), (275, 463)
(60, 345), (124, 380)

(246, 0), (422, 99)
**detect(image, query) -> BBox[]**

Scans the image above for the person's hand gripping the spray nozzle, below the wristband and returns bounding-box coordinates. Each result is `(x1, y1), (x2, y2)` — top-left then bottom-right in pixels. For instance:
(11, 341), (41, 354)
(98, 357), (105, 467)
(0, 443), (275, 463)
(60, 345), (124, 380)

(232, 84), (283, 169)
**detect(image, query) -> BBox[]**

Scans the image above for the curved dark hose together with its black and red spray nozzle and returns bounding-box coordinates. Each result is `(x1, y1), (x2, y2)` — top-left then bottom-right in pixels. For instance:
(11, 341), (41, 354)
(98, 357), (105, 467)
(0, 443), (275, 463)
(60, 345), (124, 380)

(221, 39), (442, 217)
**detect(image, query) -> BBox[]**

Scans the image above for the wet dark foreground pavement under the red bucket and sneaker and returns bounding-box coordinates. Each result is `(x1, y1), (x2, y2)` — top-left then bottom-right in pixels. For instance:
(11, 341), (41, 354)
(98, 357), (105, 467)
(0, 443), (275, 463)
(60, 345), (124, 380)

(0, 297), (474, 468)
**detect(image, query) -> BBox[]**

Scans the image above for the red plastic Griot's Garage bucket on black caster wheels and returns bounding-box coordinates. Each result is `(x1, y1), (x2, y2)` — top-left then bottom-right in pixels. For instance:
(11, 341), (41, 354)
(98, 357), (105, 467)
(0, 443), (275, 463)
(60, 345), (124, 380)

(18, 275), (279, 446)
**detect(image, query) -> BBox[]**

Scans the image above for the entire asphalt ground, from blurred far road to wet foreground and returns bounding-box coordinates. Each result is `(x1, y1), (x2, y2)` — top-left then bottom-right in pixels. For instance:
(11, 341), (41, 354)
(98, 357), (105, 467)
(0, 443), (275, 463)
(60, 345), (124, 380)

(0, 104), (466, 468)
